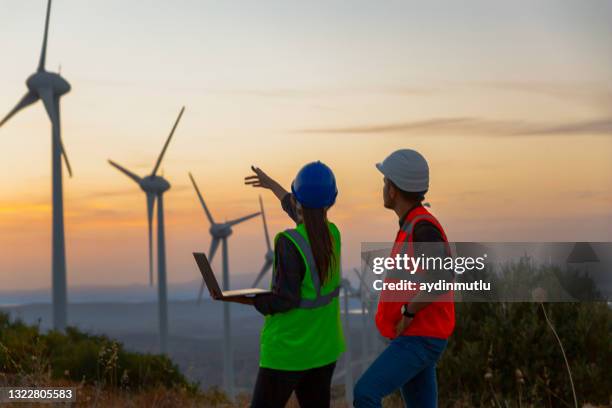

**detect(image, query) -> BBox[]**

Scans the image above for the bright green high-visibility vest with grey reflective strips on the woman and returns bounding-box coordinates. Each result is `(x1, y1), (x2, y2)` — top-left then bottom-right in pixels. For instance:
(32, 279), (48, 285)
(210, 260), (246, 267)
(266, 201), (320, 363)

(259, 222), (346, 371)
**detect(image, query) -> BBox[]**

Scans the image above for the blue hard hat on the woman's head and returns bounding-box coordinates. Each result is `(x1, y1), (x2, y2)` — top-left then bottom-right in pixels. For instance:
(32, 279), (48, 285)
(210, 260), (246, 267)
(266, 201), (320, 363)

(291, 161), (338, 208)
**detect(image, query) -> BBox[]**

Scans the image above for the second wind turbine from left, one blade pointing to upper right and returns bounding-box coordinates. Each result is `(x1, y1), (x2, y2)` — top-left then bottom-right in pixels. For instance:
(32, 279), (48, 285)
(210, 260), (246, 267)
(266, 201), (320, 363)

(108, 106), (185, 354)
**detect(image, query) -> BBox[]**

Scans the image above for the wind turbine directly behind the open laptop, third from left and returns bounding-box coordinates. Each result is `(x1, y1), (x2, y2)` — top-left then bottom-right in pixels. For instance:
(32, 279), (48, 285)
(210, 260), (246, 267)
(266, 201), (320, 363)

(189, 173), (260, 399)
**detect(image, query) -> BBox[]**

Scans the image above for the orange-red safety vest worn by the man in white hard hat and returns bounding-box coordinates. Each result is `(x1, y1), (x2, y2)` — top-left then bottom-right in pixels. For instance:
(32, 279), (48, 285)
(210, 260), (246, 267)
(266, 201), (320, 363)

(376, 206), (455, 339)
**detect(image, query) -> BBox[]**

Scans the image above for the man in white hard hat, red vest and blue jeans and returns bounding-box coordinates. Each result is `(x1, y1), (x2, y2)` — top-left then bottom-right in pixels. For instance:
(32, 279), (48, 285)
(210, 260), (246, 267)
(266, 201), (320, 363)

(353, 149), (455, 408)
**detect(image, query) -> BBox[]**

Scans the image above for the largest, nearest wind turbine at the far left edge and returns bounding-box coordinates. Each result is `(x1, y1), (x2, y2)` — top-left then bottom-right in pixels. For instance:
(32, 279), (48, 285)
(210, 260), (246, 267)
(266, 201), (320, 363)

(0, 0), (72, 330)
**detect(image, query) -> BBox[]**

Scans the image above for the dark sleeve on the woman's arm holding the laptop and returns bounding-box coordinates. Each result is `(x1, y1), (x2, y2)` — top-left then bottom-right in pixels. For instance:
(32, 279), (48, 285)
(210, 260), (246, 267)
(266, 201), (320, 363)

(254, 235), (306, 315)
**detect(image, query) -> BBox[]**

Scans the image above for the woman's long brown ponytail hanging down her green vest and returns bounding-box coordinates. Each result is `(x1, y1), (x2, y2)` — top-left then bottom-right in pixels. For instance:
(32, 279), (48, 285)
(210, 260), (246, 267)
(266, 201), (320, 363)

(302, 207), (336, 285)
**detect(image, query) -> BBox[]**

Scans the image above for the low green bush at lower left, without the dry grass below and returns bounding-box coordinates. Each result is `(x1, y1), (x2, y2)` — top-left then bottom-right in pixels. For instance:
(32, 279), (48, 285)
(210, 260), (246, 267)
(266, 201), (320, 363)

(0, 313), (197, 390)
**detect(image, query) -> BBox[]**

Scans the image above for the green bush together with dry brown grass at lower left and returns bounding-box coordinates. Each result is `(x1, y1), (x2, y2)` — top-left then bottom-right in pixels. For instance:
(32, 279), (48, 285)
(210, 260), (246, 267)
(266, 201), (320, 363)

(0, 313), (231, 407)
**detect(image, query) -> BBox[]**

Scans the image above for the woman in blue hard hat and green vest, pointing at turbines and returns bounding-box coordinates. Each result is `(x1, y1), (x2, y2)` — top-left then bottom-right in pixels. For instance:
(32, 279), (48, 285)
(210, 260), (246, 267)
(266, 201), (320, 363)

(241, 161), (345, 408)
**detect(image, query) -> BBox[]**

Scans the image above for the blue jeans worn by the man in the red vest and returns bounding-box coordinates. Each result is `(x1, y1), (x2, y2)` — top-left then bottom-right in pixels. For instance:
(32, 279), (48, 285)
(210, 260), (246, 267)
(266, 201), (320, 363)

(353, 336), (448, 408)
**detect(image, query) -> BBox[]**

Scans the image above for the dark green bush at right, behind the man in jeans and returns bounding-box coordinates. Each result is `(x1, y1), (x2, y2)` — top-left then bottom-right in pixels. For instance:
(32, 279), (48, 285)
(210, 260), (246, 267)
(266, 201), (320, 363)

(438, 263), (612, 407)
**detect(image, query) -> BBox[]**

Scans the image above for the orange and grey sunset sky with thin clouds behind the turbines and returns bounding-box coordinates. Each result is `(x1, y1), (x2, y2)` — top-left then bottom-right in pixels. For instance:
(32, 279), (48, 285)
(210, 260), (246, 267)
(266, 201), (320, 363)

(0, 0), (612, 290)
